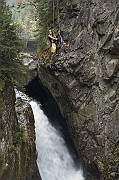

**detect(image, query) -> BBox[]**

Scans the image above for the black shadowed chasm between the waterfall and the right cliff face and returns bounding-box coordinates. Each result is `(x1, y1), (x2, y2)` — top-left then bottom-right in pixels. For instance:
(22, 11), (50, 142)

(25, 77), (81, 170)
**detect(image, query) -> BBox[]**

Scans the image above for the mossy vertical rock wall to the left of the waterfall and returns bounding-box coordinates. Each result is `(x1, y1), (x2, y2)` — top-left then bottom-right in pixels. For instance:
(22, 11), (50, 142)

(0, 80), (41, 180)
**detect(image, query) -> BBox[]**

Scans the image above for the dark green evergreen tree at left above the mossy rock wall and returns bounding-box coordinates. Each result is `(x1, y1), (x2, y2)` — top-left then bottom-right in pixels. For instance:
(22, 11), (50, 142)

(0, 0), (28, 88)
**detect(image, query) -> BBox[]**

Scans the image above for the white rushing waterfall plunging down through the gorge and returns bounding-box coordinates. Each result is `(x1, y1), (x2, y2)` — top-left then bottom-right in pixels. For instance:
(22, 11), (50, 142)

(30, 101), (84, 180)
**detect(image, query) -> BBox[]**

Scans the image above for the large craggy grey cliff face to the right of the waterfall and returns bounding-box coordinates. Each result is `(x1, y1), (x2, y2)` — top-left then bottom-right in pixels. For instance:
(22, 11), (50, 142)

(39, 0), (119, 180)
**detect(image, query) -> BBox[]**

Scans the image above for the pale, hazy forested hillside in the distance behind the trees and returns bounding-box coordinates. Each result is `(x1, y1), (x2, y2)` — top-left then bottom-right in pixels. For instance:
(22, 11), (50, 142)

(11, 4), (36, 39)
